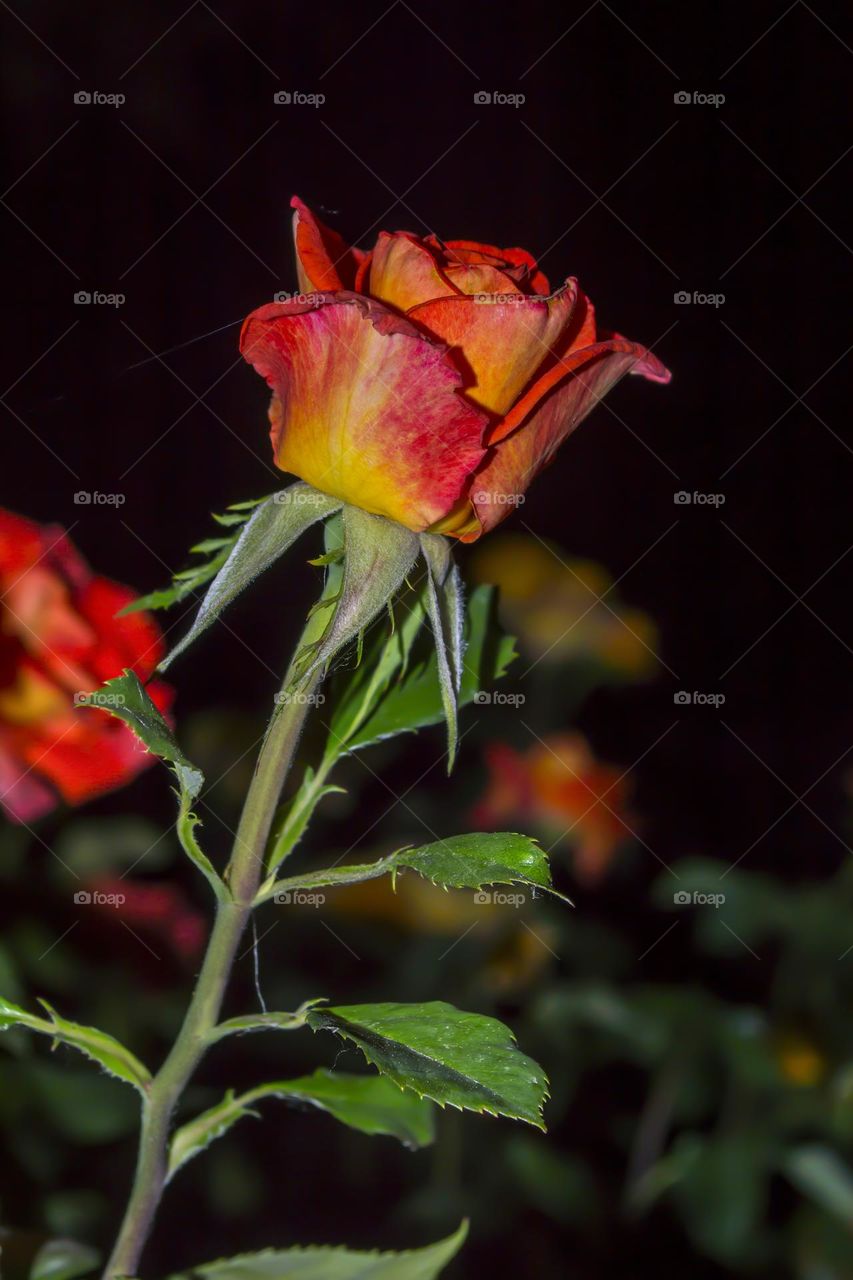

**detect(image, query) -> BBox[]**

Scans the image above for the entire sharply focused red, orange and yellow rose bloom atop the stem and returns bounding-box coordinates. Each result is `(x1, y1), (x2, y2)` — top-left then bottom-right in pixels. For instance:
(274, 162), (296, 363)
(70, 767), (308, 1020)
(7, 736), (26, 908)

(241, 197), (670, 541)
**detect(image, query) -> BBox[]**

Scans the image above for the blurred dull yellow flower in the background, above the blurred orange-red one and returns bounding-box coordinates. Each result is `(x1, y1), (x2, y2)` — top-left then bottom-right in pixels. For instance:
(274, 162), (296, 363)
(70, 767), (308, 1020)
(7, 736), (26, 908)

(470, 532), (658, 678)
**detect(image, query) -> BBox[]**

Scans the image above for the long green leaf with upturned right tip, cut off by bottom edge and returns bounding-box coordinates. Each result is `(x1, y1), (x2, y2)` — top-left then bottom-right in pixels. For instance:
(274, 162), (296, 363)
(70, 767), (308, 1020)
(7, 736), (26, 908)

(163, 1222), (467, 1280)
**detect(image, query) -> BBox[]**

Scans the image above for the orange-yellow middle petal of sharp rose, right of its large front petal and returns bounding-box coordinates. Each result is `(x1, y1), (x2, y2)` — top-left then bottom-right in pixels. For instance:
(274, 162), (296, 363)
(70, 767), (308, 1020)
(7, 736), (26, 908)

(409, 280), (578, 415)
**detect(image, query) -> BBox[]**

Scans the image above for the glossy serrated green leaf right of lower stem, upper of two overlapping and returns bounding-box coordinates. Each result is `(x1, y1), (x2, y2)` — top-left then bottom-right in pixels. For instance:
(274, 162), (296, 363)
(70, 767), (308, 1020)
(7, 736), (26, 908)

(306, 1001), (548, 1129)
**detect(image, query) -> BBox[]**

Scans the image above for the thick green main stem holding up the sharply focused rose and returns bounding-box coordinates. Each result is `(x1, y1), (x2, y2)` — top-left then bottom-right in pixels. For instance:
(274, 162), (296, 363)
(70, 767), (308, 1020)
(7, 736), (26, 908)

(104, 672), (321, 1280)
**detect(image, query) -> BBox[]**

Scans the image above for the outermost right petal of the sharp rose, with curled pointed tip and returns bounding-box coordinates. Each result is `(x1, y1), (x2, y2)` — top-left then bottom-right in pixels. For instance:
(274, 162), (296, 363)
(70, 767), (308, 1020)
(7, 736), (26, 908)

(457, 335), (670, 541)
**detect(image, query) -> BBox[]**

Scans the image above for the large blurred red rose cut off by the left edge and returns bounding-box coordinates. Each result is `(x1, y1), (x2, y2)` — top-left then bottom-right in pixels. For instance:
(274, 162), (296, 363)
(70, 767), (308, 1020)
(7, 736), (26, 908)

(0, 508), (172, 823)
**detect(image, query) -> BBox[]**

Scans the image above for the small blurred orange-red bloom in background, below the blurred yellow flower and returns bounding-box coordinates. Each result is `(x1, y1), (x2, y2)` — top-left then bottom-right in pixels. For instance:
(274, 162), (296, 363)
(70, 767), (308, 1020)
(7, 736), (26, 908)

(473, 733), (631, 884)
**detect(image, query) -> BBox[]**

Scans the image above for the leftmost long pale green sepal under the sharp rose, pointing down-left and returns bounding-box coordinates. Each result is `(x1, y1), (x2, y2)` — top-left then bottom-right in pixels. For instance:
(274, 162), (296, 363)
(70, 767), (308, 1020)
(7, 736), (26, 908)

(160, 480), (341, 671)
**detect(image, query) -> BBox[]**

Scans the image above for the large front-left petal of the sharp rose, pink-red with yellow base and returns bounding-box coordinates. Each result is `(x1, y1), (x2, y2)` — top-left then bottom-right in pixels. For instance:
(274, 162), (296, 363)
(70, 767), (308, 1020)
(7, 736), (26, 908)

(241, 293), (489, 530)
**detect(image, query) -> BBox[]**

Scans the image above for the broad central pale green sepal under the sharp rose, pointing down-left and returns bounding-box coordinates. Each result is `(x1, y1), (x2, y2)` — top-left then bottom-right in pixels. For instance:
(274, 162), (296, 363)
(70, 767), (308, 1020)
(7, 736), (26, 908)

(297, 506), (419, 682)
